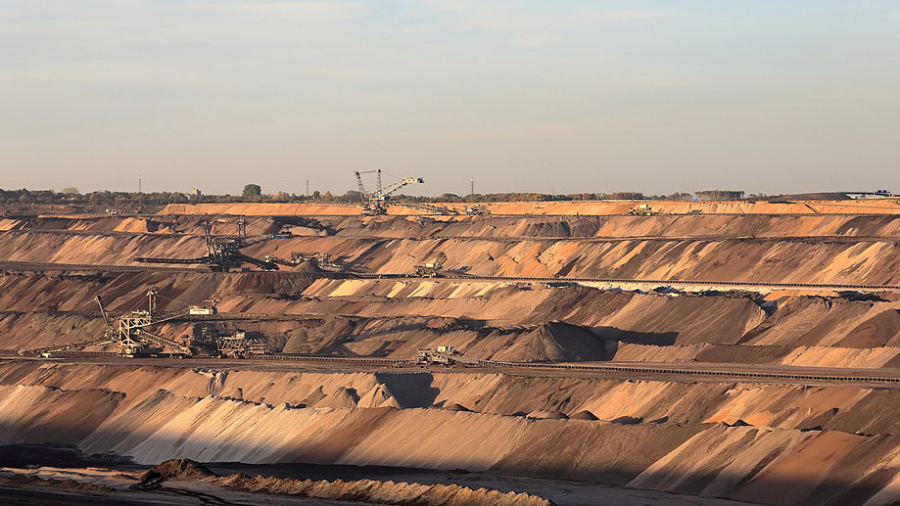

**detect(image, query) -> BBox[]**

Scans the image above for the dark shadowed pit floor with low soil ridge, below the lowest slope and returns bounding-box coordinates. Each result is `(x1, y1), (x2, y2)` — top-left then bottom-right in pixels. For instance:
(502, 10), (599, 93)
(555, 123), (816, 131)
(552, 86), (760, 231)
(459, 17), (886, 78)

(0, 445), (744, 506)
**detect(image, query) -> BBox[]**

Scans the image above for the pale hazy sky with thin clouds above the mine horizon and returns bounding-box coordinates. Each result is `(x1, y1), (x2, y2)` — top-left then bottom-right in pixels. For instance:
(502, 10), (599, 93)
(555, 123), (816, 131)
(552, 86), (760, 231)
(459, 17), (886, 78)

(0, 0), (900, 195)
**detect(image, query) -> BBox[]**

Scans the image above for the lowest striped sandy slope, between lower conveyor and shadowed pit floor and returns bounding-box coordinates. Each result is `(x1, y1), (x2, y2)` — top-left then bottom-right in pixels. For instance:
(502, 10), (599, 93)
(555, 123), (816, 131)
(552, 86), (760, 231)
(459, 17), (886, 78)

(0, 362), (897, 504)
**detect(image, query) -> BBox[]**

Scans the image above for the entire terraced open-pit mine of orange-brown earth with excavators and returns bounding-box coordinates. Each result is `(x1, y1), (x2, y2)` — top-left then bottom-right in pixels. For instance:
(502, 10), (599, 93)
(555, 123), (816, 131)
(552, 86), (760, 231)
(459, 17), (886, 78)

(0, 198), (900, 506)
